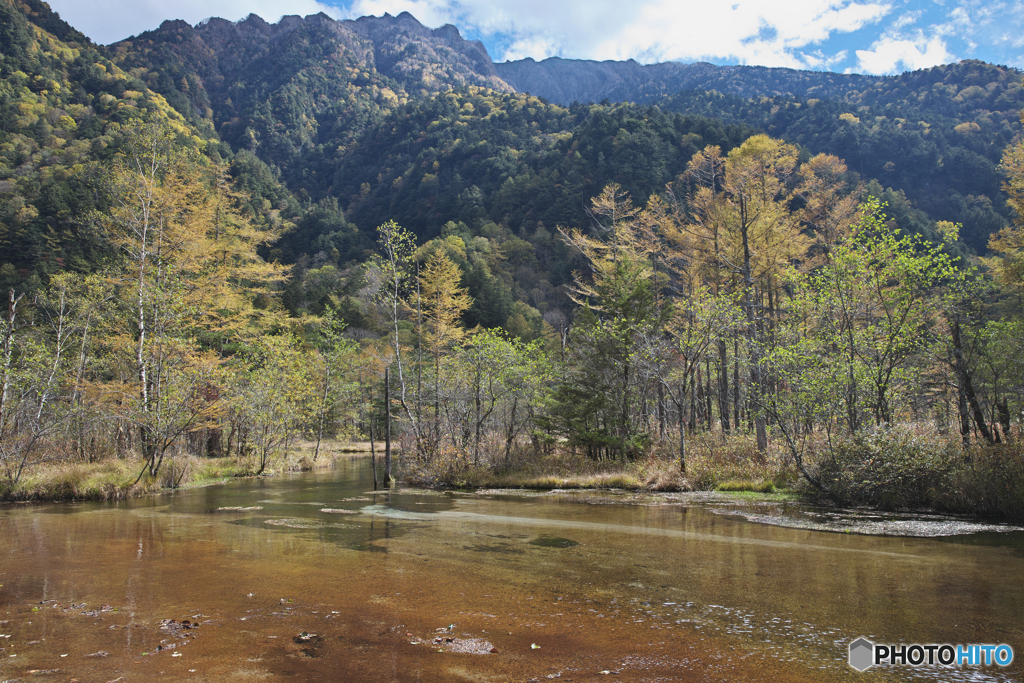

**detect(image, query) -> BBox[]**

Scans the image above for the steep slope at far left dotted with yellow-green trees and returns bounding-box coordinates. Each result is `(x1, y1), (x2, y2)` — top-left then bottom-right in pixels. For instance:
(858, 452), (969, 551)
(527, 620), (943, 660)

(0, 0), (199, 280)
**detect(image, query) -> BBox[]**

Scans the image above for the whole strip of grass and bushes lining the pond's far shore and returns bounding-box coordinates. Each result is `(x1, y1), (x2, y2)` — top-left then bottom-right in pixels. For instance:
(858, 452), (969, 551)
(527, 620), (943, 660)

(8, 428), (1024, 521)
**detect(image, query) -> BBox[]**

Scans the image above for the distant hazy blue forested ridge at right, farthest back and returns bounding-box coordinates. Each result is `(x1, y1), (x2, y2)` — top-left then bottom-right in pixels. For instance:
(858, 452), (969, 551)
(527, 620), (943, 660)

(496, 57), (1024, 252)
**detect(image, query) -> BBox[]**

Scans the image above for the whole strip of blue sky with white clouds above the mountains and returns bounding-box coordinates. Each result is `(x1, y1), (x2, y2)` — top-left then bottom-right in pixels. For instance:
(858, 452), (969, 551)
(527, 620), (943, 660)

(49, 0), (1024, 75)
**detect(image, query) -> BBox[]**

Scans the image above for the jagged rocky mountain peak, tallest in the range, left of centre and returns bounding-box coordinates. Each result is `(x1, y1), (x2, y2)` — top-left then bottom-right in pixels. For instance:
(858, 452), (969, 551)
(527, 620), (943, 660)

(110, 12), (511, 196)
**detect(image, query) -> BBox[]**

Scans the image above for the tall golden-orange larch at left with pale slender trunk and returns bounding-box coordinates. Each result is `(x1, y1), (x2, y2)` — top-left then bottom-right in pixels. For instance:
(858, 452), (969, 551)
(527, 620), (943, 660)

(94, 124), (287, 477)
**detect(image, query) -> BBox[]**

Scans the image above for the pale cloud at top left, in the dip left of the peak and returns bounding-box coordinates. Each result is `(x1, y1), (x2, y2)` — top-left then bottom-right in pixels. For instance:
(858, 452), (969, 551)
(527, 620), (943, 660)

(48, 0), (341, 45)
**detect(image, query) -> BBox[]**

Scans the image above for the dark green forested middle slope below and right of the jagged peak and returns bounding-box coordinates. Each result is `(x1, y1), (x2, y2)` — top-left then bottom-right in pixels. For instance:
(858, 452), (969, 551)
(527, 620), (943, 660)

(334, 88), (749, 249)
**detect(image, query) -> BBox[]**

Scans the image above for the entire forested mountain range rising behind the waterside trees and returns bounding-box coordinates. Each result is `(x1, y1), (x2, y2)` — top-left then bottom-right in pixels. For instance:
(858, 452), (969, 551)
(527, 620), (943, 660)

(6, 0), (1024, 327)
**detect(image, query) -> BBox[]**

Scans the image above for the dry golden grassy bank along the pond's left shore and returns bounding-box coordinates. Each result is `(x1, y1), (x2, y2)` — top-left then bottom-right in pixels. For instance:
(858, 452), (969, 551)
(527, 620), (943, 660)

(0, 441), (368, 503)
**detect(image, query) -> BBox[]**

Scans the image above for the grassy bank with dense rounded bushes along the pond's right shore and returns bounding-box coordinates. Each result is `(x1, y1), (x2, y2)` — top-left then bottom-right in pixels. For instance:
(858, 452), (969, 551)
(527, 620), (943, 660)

(400, 427), (1024, 520)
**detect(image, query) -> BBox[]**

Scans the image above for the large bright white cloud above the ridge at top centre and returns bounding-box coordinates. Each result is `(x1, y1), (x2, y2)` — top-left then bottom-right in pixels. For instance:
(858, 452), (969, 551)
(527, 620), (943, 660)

(348, 0), (892, 68)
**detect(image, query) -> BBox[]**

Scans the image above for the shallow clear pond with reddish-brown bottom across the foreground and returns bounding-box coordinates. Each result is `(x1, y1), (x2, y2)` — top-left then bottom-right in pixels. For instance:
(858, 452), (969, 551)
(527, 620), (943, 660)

(0, 459), (1024, 682)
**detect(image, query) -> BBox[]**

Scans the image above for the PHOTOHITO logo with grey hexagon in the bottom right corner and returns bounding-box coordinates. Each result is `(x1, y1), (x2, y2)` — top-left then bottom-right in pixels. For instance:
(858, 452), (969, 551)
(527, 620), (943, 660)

(849, 638), (1014, 671)
